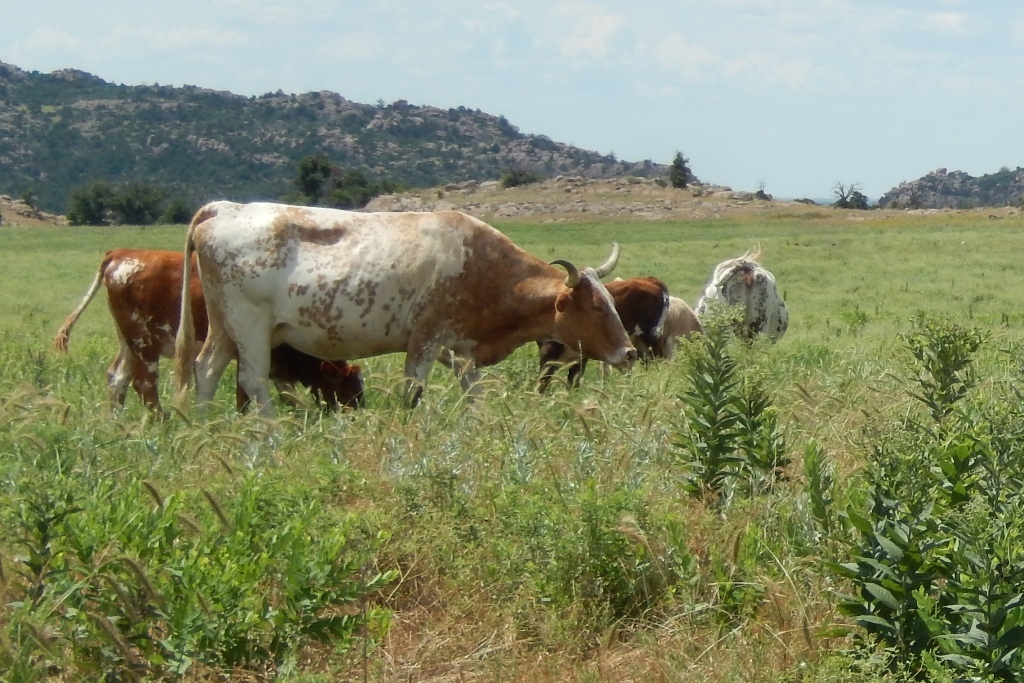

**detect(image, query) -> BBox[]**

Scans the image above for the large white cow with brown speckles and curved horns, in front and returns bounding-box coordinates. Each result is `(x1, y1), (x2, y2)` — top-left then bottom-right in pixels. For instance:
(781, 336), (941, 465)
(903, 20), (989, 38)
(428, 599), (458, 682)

(174, 202), (636, 414)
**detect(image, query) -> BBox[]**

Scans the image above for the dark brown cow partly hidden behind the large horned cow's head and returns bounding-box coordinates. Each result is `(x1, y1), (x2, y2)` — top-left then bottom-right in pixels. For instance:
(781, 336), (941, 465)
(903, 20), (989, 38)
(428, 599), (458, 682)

(537, 278), (670, 393)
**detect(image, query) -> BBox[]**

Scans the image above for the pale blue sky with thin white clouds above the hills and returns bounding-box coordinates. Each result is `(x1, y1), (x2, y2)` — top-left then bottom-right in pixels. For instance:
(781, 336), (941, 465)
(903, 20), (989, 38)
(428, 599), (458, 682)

(0, 0), (1024, 199)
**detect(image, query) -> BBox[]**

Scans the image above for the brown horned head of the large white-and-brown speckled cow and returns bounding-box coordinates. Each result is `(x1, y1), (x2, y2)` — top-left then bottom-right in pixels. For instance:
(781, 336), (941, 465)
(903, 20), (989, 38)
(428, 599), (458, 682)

(551, 244), (637, 367)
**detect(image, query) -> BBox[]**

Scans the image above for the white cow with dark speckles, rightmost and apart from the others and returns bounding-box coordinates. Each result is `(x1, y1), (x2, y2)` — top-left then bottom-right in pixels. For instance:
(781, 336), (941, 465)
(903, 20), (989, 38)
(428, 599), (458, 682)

(696, 248), (790, 342)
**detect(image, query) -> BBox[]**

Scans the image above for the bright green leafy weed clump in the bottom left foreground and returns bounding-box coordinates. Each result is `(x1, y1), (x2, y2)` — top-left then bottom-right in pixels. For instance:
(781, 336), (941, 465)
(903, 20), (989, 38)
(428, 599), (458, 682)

(9, 474), (395, 680)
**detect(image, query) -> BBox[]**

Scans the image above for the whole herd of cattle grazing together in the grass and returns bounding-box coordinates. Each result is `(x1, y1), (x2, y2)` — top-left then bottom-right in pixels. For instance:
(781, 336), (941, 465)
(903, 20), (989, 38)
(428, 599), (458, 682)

(54, 202), (788, 415)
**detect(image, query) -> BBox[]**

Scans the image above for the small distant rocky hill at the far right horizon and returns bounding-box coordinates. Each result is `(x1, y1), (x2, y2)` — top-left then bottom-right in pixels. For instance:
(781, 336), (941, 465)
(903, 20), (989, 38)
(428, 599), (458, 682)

(879, 167), (1024, 209)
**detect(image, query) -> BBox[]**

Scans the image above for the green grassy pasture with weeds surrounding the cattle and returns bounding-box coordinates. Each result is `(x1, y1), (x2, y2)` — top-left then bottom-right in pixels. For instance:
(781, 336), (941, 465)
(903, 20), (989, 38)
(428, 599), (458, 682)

(0, 209), (1024, 682)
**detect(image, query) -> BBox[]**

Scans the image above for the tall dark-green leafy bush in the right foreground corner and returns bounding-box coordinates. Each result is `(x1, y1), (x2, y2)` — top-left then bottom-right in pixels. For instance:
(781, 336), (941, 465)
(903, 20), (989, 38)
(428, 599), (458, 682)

(830, 319), (1024, 681)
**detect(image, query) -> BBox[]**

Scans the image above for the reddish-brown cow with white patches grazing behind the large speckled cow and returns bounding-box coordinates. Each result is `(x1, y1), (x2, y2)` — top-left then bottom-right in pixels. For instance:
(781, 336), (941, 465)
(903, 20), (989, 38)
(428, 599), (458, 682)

(53, 249), (362, 411)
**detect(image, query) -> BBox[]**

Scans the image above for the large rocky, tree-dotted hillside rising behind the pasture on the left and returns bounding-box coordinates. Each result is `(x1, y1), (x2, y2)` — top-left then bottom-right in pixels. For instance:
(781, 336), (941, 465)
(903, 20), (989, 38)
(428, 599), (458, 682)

(0, 62), (673, 213)
